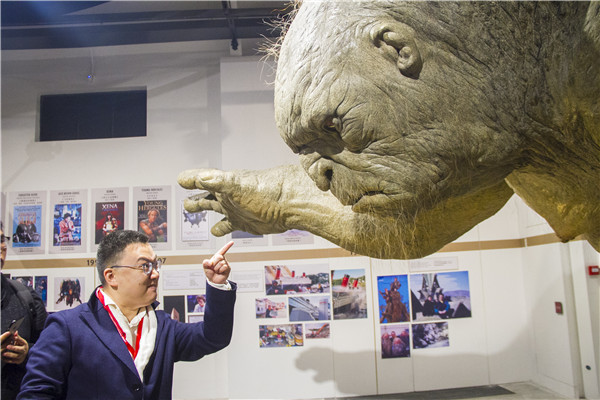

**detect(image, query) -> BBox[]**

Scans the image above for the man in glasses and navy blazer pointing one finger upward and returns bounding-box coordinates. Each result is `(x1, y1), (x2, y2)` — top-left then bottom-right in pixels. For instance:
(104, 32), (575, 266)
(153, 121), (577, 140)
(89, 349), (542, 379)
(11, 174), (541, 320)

(18, 231), (236, 400)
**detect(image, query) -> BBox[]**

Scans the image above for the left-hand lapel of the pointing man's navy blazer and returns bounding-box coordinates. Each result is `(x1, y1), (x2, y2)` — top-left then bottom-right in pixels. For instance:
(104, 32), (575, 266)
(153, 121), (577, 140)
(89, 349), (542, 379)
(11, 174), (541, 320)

(80, 290), (139, 378)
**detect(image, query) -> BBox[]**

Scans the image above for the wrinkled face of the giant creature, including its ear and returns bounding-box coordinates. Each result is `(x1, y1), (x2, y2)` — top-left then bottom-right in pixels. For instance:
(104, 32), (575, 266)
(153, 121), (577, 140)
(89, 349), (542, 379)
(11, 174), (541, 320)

(275, 2), (519, 213)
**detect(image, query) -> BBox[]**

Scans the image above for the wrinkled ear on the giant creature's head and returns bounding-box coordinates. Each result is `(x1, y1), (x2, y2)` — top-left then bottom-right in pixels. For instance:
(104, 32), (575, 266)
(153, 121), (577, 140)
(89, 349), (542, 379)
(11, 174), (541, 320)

(371, 22), (423, 79)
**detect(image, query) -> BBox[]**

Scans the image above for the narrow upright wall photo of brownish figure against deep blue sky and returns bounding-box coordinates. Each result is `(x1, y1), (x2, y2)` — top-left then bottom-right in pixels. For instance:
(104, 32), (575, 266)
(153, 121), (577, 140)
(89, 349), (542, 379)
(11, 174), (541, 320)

(377, 275), (410, 324)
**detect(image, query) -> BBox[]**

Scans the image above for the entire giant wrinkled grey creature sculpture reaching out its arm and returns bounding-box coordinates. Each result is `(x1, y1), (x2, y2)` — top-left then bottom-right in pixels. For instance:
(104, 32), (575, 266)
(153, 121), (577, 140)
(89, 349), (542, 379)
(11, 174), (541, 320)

(179, 1), (600, 258)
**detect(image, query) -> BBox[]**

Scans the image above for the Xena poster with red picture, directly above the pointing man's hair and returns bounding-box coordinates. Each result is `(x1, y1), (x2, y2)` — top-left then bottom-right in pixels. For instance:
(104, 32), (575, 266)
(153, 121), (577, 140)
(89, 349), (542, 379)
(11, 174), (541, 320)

(92, 188), (129, 251)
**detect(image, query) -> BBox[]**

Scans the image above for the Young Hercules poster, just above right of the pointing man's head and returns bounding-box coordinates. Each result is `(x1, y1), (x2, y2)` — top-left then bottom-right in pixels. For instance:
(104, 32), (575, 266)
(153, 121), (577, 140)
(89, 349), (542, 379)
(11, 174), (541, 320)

(133, 186), (172, 250)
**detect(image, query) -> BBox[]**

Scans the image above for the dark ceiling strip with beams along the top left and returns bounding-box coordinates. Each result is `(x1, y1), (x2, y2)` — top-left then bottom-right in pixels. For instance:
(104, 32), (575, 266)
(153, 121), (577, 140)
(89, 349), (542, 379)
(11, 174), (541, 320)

(0, 1), (288, 50)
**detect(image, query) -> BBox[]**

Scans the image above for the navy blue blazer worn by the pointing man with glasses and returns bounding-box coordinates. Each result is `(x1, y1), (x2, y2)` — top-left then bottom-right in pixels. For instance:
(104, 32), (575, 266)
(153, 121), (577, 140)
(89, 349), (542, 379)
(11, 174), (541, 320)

(17, 283), (236, 400)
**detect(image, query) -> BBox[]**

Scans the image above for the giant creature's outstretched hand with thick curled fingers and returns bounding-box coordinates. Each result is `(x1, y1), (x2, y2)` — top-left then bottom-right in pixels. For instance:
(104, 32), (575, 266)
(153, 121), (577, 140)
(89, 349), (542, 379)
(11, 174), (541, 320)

(177, 167), (300, 236)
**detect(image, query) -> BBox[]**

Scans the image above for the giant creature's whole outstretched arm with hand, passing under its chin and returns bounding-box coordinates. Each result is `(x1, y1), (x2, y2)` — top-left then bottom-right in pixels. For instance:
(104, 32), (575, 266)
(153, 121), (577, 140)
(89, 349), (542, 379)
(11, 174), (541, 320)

(178, 165), (512, 258)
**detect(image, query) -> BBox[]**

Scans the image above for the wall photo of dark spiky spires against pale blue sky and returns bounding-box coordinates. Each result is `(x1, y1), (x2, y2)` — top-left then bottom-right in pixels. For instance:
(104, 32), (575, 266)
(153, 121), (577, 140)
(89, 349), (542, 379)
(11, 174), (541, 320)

(410, 271), (471, 322)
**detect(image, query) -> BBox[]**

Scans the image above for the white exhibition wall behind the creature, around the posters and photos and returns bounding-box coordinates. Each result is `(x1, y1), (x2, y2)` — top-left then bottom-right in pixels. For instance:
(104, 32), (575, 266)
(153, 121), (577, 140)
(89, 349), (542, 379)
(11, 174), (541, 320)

(1, 42), (600, 399)
